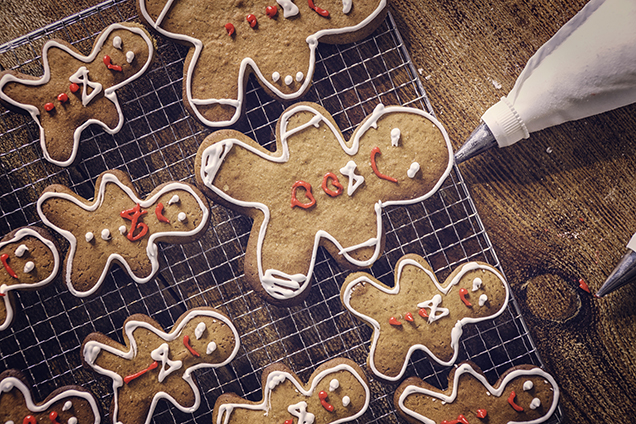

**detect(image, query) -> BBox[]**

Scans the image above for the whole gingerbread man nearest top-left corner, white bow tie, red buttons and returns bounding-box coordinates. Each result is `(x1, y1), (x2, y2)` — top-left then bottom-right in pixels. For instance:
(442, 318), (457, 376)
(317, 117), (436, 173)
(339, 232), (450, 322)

(0, 23), (154, 166)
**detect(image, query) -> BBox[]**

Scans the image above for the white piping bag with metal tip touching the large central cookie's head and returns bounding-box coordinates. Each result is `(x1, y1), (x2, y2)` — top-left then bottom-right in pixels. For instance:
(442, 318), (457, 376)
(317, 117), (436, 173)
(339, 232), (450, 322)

(455, 0), (636, 163)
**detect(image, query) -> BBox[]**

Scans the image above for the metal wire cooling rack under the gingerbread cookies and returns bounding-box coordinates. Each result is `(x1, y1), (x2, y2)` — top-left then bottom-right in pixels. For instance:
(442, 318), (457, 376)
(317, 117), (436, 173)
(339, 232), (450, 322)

(0, 0), (561, 424)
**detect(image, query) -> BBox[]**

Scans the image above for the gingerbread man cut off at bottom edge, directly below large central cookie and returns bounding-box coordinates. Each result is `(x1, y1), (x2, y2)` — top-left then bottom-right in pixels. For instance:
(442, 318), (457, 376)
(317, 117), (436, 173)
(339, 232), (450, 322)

(212, 358), (371, 424)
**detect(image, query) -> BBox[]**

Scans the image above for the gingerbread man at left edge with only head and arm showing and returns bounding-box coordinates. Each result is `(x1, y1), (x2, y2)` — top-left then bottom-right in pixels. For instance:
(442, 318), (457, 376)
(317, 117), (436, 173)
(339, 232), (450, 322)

(0, 227), (60, 331)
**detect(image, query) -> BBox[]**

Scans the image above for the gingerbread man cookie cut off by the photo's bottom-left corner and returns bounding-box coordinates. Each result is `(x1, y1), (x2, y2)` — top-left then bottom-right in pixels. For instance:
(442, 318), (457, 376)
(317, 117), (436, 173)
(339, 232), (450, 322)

(0, 370), (101, 424)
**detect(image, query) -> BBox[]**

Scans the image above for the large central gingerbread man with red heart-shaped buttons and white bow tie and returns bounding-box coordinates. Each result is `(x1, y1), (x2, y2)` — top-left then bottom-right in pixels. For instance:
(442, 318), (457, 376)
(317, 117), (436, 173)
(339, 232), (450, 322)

(195, 103), (453, 306)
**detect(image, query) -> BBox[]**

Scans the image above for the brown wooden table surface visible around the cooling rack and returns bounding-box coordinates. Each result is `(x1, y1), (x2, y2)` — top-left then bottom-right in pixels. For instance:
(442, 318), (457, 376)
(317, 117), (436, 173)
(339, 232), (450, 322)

(0, 0), (636, 423)
